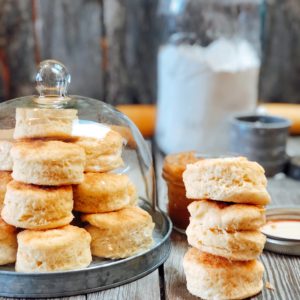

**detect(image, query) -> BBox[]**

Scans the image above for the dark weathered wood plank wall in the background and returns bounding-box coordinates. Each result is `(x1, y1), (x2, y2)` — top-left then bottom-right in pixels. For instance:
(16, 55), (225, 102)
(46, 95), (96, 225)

(0, 0), (300, 104)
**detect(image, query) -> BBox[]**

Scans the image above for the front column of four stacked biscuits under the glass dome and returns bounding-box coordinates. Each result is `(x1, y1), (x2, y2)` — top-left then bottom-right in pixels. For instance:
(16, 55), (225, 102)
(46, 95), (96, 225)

(1, 108), (92, 272)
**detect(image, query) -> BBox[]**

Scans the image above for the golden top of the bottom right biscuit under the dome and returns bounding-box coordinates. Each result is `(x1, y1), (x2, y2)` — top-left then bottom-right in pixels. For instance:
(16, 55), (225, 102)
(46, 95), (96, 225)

(82, 207), (152, 230)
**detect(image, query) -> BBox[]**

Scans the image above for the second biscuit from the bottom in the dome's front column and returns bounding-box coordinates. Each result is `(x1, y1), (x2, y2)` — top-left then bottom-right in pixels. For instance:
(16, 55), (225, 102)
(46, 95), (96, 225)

(1, 180), (73, 229)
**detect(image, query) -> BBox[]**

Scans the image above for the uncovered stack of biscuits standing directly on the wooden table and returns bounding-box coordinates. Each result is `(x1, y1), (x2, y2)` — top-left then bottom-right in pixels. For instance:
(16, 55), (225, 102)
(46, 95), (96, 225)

(183, 157), (270, 299)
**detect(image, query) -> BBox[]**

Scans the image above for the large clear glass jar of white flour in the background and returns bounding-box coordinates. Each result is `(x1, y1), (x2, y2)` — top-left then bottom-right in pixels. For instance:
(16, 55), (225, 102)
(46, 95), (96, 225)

(156, 0), (260, 154)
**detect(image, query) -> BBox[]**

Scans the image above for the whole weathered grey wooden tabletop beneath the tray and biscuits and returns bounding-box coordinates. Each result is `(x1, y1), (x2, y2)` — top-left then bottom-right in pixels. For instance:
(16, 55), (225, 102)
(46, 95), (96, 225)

(0, 137), (300, 300)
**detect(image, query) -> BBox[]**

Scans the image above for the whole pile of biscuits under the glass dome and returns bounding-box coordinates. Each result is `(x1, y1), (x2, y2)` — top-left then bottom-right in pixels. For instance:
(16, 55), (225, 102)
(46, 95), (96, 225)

(0, 108), (153, 272)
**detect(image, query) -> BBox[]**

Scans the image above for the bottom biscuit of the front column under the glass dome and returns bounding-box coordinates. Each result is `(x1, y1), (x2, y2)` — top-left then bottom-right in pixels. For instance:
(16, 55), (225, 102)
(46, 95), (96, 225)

(16, 225), (92, 272)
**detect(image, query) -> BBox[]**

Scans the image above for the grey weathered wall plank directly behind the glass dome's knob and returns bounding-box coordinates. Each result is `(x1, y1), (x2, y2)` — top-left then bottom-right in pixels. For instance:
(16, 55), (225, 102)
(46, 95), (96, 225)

(35, 0), (103, 99)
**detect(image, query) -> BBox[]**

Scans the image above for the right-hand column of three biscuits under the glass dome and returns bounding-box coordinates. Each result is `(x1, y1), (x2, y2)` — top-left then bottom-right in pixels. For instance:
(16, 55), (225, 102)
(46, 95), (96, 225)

(73, 124), (154, 259)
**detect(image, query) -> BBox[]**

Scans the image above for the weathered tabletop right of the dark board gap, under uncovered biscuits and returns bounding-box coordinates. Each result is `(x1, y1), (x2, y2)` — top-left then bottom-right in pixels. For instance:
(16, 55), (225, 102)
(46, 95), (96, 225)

(155, 138), (300, 300)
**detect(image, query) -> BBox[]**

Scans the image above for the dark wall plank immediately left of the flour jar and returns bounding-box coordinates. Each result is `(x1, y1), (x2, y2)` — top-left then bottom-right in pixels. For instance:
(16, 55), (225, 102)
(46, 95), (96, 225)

(104, 0), (157, 104)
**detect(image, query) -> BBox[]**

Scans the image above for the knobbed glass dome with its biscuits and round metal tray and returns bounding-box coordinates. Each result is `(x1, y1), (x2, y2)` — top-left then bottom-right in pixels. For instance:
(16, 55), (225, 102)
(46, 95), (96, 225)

(0, 60), (172, 298)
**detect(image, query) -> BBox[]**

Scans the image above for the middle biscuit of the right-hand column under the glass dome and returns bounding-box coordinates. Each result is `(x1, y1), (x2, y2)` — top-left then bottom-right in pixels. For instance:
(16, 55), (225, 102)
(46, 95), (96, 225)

(73, 173), (137, 213)
